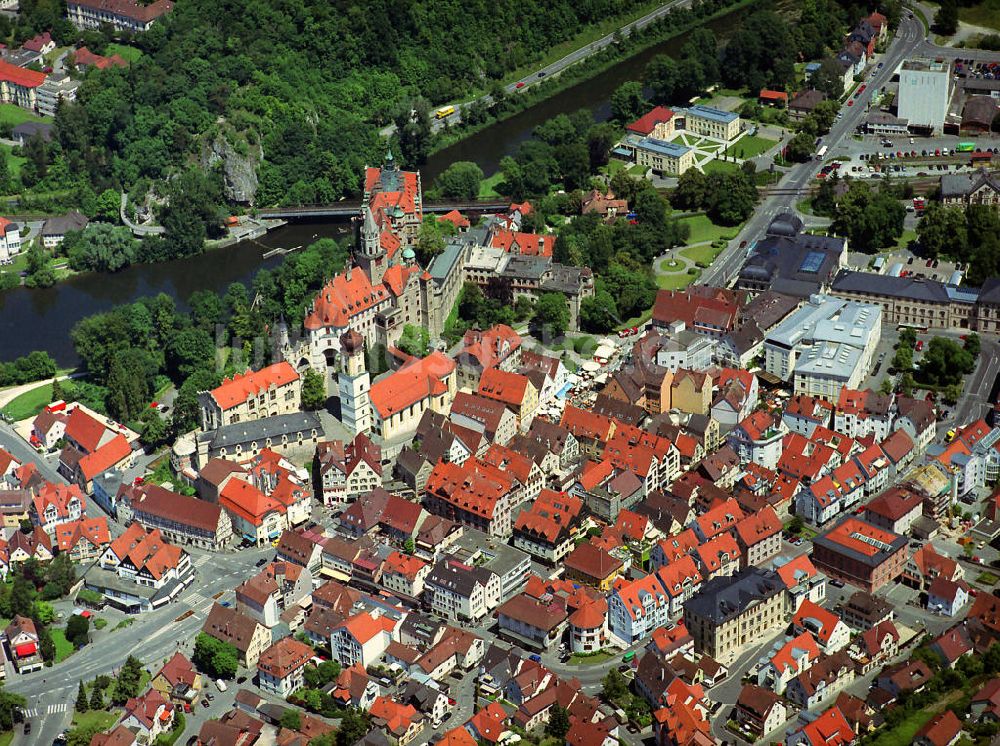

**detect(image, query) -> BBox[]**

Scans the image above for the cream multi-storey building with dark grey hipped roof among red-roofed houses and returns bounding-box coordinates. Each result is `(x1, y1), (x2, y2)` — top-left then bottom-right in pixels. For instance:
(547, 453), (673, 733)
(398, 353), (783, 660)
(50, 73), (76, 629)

(684, 567), (785, 660)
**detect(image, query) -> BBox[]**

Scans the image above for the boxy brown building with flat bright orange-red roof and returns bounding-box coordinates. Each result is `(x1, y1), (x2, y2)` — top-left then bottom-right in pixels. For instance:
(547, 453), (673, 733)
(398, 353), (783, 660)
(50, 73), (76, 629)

(812, 516), (907, 593)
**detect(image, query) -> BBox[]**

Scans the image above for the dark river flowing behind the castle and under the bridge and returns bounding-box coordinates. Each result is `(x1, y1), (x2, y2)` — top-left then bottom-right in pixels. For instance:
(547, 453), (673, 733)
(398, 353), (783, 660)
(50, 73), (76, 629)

(0, 0), (749, 366)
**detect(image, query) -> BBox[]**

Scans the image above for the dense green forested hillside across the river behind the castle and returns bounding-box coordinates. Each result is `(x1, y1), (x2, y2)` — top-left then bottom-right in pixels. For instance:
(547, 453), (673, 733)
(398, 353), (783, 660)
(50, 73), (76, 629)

(50, 0), (652, 204)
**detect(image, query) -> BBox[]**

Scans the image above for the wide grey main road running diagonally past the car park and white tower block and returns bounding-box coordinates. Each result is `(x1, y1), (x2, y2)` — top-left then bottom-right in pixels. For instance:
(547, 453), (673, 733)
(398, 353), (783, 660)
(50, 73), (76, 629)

(699, 17), (924, 287)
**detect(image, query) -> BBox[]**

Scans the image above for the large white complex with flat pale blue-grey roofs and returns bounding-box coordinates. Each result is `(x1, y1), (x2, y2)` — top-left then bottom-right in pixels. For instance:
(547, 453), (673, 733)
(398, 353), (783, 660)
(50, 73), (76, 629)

(764, 294), (882, 401)
